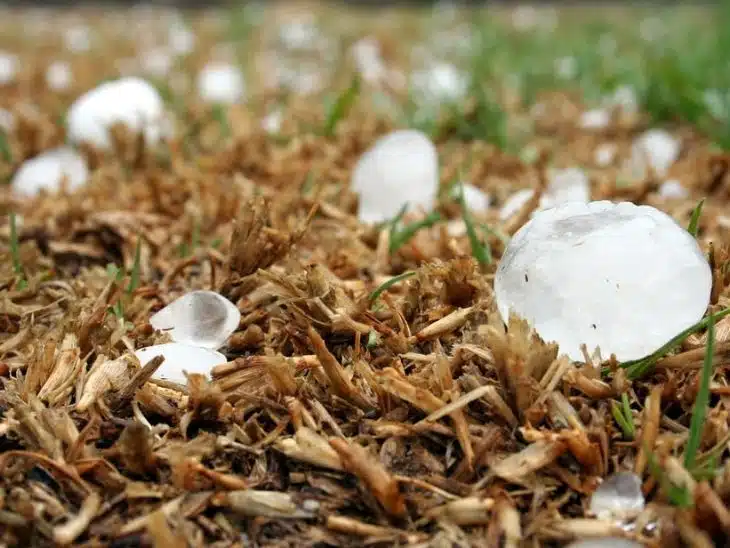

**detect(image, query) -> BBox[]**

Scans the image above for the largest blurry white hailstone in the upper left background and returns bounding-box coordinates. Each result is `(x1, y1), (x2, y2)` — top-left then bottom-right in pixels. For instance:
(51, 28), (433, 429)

(67, 77), (168, 149)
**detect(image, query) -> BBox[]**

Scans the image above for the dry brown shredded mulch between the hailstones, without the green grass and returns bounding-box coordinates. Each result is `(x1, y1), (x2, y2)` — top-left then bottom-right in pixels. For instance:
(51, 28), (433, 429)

(0, 4), (730, 547)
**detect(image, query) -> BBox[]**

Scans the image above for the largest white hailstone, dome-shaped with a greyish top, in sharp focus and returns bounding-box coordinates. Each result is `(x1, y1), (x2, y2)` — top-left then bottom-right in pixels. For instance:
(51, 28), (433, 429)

(494, 201), (712, 361)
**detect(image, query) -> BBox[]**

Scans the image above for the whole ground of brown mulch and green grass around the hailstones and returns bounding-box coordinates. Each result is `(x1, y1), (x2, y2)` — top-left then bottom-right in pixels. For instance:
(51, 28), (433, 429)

(0, 1), (730, 547)
